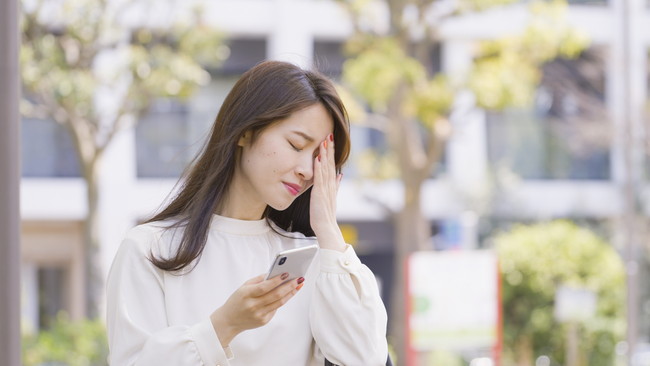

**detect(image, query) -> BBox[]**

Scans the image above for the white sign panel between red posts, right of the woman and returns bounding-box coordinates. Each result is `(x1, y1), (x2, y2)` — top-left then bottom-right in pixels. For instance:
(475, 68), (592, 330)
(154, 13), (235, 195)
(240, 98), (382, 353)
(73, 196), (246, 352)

(408, 250), (500, 352)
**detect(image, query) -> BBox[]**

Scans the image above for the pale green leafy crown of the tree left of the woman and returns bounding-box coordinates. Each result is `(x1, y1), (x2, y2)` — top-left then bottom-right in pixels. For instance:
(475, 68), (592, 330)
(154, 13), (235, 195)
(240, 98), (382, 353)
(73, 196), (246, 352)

(20, 0), (227, 124)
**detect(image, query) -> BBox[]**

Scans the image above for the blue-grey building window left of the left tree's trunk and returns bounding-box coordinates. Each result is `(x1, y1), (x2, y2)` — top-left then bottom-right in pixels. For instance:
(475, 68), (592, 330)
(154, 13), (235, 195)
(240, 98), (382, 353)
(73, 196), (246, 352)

(21, 118), (81, 178)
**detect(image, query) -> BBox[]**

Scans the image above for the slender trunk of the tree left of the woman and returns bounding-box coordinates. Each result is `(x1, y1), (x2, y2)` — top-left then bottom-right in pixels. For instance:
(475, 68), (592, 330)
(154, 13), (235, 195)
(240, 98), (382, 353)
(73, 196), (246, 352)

(83, 157), (103, 319)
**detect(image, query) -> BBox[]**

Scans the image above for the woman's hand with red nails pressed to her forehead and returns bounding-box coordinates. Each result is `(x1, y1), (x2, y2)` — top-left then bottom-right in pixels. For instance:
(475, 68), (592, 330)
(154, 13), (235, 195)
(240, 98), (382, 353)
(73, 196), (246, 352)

(309, 134), (345, 251)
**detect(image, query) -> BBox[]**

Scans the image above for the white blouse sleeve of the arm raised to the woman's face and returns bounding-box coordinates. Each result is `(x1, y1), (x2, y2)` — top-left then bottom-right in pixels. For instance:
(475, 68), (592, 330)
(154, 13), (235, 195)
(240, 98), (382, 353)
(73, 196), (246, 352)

(309, 245), (388, 366)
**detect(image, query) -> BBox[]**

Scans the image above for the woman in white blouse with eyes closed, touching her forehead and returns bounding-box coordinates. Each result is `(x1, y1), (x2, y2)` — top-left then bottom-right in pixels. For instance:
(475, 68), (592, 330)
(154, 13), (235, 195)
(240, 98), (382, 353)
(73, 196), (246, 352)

(107, 61), (387, 366)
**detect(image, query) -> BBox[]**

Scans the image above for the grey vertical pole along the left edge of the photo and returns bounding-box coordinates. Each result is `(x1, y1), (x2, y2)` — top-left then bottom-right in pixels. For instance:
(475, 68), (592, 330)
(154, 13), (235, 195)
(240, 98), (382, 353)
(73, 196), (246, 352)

(0, 0), (20, 366)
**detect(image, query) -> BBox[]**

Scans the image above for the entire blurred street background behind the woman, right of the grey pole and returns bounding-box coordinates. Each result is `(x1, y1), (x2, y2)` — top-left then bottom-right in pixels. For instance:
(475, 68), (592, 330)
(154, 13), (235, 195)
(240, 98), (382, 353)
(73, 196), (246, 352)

(8, 0), (650, 366)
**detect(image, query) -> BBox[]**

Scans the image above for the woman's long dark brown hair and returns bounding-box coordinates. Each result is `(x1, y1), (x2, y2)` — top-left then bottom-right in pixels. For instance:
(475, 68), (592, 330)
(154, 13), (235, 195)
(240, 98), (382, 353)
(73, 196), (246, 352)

(147, 61), (350, 271)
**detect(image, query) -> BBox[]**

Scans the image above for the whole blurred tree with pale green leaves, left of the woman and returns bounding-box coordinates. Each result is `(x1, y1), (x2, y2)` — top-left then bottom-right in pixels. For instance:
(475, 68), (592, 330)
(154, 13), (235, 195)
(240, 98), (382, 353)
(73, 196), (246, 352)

(20, 0), (223, 316)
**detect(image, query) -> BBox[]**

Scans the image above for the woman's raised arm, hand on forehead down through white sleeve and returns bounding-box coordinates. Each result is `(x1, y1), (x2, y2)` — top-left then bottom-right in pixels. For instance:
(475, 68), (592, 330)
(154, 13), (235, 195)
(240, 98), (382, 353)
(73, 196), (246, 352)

(309, 135), (388, 366)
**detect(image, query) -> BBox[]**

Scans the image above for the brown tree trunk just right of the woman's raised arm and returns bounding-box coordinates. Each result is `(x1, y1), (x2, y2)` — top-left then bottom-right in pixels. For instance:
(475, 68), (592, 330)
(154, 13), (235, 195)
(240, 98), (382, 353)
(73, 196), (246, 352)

(390, 179), (431, 366)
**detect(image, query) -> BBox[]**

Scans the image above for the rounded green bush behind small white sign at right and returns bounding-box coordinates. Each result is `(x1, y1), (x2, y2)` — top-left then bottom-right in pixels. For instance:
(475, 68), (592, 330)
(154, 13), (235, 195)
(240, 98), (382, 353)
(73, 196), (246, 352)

(494, 221), (625, 366)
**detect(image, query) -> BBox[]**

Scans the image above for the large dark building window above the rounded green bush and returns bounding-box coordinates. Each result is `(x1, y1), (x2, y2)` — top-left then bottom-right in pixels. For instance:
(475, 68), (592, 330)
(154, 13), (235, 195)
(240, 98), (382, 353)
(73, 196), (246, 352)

(487, 49), (612, 180)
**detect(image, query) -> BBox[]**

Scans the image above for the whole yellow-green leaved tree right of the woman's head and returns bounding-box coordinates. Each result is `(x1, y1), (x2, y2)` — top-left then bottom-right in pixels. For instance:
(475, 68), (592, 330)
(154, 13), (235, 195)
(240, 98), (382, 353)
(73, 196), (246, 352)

(341, 0), (586, 360)
